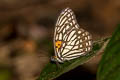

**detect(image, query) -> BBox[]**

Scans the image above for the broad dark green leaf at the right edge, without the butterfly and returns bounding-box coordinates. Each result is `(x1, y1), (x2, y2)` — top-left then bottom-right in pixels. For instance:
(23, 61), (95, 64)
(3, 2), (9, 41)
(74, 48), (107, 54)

(97, 24), (120, 80)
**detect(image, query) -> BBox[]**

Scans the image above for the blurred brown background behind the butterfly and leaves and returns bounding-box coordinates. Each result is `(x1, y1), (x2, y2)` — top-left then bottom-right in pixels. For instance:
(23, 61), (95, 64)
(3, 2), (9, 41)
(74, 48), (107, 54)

(0, 0), (120, 80)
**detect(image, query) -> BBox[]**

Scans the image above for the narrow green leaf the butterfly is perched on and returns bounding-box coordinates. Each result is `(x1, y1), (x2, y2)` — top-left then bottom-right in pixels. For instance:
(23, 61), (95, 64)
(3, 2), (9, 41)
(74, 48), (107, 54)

(37, 38), (109, 80)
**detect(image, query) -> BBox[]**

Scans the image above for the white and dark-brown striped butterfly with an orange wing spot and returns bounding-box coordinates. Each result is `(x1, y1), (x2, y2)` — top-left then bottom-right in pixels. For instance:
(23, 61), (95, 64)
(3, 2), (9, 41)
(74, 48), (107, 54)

(51, 8), (92, 63)
